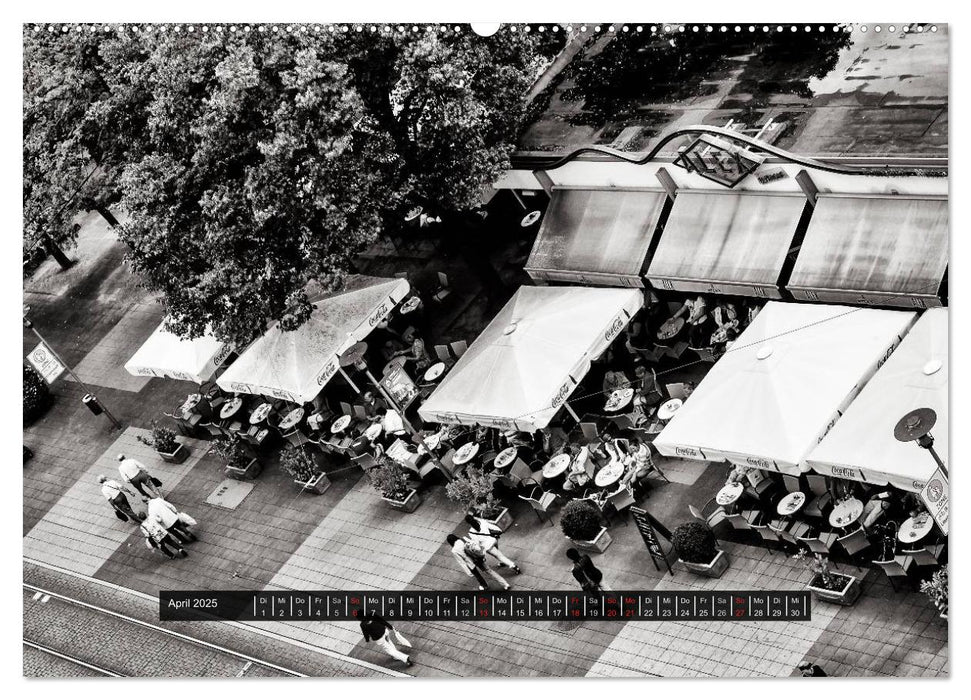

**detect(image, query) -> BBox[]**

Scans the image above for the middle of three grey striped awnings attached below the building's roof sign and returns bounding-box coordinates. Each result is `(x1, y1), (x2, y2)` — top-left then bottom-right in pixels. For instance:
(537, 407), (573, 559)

(647, 191), (807, 299)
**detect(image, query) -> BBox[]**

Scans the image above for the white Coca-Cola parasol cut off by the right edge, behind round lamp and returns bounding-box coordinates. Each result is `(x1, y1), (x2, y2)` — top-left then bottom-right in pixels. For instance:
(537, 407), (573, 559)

(807, 309), (950, 492)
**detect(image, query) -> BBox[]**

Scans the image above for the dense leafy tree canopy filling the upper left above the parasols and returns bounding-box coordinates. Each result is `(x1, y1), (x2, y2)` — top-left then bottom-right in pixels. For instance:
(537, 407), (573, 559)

(24, 25), (546, 344)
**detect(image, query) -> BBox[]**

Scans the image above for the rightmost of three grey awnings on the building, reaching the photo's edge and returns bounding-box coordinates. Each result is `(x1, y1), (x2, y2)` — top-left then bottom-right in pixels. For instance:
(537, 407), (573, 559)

(786, 195), (948, 309)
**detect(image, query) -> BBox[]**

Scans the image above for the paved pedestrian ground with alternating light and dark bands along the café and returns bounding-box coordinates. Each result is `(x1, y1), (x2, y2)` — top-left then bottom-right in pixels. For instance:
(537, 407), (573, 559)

(23, 205), (948, 676)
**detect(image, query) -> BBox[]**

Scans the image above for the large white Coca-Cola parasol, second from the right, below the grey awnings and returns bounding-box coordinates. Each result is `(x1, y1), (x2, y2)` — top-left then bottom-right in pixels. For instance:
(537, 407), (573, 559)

(654, 301), (917, 475)
